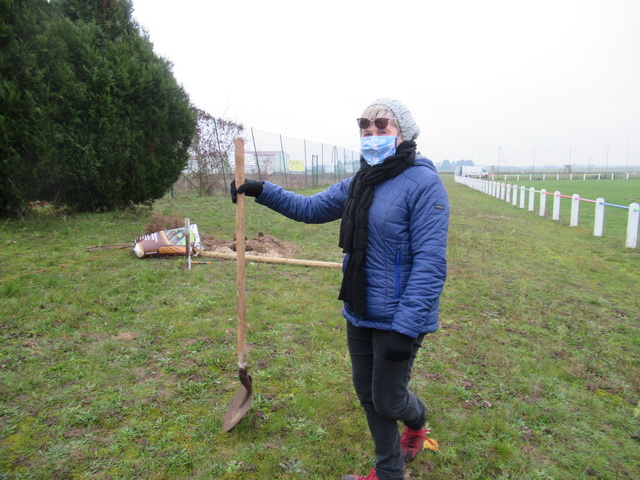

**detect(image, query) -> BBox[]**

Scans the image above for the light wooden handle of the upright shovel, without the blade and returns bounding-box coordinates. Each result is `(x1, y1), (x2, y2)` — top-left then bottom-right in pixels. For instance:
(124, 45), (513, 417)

(235, 138), (247, 369)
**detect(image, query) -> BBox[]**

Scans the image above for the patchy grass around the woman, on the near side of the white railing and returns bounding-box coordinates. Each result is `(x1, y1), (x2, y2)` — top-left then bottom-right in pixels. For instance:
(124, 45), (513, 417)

(0, 177), (640, 480)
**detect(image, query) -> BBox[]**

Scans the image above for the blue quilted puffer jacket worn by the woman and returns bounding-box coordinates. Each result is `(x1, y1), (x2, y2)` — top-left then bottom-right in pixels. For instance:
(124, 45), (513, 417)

(256, 158), (449, 338)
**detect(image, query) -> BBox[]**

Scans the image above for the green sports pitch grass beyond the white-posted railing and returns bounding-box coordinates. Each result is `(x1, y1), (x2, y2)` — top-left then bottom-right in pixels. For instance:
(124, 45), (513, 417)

(462, 175), (640, 245)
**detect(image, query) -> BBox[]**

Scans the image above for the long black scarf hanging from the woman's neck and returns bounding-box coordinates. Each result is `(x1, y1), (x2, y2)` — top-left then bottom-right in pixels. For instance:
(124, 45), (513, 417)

(338, 140), (416, 315)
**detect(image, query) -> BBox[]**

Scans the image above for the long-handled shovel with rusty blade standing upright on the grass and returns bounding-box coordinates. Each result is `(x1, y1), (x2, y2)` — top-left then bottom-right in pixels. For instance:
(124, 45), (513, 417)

(222, 138), (253, 432)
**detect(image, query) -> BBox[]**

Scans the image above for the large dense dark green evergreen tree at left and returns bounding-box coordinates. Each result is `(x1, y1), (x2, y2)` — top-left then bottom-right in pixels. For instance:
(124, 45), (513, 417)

(0, 0), (195, 215)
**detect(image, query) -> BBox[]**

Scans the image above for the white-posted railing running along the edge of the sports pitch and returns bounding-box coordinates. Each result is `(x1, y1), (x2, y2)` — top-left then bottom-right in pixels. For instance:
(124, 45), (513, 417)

(455, 175), (640, 248)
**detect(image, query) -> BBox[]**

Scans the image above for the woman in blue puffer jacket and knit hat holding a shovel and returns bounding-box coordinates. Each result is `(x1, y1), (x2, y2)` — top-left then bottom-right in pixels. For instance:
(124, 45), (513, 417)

(231, 99), (449, 480)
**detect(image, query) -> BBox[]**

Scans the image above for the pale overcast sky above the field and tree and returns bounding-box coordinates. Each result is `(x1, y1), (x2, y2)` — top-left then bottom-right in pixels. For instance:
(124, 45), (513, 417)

(133, 0), (640, 168)
